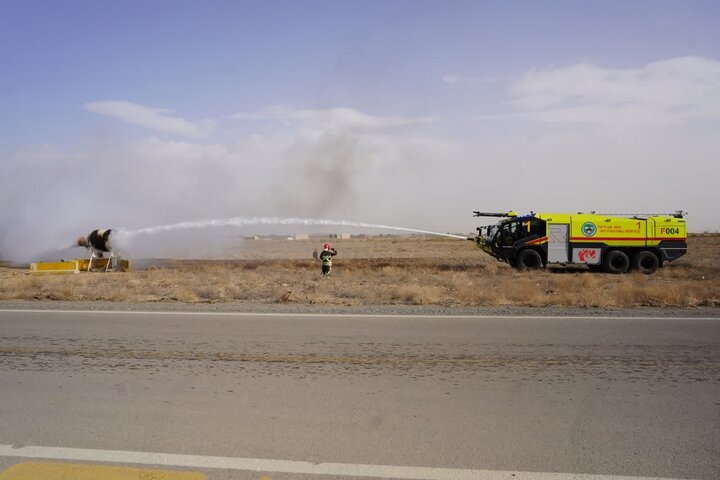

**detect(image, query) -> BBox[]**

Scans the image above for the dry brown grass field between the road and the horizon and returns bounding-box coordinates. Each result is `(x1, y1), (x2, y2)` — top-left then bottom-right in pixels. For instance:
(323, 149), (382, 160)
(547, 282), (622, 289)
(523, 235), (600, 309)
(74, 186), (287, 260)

(0, 234), (720, 307)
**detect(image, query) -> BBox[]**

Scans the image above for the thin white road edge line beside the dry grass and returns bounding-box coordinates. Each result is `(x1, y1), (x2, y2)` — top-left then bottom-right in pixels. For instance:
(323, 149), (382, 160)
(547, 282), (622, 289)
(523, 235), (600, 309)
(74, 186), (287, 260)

(0, 308), (720, 321)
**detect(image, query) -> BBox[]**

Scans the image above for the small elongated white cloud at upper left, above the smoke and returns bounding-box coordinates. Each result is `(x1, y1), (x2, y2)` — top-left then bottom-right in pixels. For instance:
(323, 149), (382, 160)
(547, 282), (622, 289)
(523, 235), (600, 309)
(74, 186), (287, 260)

(83, 100), (213, 136)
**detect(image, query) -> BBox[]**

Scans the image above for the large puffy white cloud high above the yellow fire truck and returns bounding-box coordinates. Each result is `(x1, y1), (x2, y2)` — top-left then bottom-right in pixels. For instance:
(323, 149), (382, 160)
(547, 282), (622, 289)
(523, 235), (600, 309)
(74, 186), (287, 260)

(511, 57), (720, 126)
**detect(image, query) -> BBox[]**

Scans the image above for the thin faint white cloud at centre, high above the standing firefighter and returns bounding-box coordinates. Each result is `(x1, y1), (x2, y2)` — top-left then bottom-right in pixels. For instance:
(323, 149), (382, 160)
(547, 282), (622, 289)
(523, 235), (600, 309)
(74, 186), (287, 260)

(232, 105), (434, 131)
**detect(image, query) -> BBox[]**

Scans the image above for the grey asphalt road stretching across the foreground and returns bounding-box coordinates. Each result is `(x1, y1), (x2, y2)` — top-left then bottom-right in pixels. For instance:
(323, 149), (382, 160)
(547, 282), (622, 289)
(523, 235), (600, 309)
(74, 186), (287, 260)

(0, 311), (720, 480)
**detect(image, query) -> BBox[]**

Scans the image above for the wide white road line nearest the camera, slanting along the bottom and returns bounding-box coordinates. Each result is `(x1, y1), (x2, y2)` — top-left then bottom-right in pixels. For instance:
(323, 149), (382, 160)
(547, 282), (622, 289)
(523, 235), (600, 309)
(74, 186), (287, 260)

(0, 445), (678, 480)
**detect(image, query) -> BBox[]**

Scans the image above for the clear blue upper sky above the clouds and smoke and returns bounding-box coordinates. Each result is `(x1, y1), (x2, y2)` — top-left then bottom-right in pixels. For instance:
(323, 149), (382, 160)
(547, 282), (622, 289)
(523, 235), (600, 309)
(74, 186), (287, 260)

(5, 1), (720, 146)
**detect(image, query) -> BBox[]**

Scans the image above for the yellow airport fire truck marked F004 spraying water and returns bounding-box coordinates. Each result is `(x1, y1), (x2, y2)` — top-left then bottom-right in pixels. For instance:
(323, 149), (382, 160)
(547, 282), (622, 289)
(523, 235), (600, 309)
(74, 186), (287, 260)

(473, 211), (687, 274)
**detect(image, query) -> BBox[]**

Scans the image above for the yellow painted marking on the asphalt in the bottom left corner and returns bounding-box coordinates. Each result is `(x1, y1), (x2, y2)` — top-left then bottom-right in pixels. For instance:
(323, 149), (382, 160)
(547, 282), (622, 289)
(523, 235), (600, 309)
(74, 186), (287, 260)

(0, 462), (207, 480)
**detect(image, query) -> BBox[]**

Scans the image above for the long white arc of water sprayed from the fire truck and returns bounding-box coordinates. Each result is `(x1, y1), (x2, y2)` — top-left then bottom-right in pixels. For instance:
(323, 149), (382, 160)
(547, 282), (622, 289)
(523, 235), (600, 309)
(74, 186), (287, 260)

(118, 217), (465, 240)
